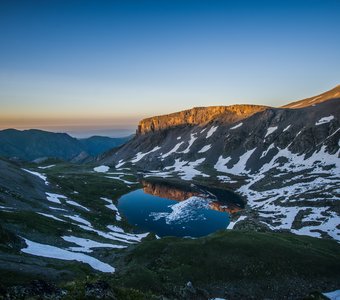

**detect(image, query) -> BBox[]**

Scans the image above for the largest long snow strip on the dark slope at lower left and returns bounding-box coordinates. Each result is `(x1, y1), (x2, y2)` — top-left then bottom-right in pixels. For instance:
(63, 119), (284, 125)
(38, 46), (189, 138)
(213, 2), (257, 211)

(21, 239), (115, 273)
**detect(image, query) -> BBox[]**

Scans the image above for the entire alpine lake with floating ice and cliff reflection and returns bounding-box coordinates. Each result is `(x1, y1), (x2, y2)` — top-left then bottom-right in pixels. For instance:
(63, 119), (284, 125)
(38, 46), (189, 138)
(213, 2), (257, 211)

(118, 180), (244, 237)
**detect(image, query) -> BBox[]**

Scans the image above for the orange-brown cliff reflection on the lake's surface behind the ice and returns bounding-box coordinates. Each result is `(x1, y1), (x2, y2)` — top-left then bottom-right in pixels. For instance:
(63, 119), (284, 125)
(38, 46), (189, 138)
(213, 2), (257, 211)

(142, 180), (241, 214)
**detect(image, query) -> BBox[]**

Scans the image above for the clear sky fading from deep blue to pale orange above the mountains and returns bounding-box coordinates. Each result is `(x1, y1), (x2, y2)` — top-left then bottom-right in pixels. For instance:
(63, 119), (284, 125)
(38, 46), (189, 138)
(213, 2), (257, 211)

(0, 0), (340, 135)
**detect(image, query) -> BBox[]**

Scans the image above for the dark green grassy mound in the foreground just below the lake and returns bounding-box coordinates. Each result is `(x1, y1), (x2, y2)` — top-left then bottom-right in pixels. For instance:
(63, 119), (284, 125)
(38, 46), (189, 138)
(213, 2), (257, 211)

(112, 231), (340, 293)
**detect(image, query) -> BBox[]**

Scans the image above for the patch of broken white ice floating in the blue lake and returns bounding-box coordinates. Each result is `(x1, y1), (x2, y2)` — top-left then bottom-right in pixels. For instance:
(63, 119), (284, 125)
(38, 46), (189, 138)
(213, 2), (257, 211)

(150, 196), (210, 224)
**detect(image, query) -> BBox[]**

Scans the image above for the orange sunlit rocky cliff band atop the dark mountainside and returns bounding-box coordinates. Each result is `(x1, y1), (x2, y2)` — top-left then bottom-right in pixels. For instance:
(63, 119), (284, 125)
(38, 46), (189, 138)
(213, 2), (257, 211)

(137, 105), (267, 135)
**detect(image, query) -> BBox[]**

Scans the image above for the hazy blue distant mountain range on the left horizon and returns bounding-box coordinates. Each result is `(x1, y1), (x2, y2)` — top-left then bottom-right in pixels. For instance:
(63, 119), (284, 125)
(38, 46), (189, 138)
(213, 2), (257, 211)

(0, 129), (131, 162)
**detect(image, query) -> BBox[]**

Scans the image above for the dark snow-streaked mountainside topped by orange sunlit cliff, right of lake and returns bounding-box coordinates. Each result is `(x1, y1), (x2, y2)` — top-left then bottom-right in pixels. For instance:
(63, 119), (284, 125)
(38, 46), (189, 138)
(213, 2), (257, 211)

(100, 86), (340, 240)
